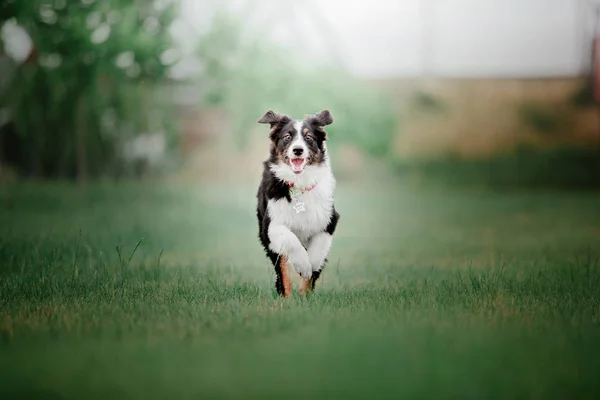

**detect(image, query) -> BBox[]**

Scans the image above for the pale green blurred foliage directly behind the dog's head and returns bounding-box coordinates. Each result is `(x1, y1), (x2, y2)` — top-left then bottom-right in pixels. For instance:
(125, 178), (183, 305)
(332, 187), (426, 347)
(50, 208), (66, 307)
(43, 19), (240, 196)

(196, 14), (397, 156)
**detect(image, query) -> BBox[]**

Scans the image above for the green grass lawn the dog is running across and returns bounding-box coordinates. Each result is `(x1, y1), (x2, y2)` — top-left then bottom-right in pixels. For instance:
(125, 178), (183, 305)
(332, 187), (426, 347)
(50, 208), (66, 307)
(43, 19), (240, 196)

(0, 181), (600, 399)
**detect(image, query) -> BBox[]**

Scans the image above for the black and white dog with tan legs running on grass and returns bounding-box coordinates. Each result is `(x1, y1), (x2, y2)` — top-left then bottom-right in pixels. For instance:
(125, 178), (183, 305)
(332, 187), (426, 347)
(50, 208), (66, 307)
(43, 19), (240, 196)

(256, 110), (340, 297)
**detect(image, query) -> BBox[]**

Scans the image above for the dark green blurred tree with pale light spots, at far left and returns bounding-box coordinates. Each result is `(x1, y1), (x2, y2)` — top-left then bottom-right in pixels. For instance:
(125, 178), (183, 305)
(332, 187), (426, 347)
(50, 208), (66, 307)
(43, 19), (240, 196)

(0, 0), (178, 181)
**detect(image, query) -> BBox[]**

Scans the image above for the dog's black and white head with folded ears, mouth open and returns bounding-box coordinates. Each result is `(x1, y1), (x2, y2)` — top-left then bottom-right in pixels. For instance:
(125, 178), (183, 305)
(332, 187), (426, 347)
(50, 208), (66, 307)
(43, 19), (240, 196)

(258, 110), (333, 175)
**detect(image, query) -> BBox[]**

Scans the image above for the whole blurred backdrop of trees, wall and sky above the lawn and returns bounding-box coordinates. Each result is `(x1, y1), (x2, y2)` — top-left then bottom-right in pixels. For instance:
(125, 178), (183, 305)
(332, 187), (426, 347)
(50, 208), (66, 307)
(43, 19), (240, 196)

(0, 0), (600, 187)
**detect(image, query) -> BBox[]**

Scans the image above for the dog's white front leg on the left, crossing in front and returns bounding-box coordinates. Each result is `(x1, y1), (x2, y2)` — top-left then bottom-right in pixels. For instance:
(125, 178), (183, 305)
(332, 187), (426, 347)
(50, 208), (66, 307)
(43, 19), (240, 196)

(268, 223), (312, 279)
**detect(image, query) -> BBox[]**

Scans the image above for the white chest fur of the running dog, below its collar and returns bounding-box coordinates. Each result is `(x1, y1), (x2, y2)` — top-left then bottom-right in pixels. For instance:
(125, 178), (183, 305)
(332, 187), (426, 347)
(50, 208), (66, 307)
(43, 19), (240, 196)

(267, 166), (335, 246)
